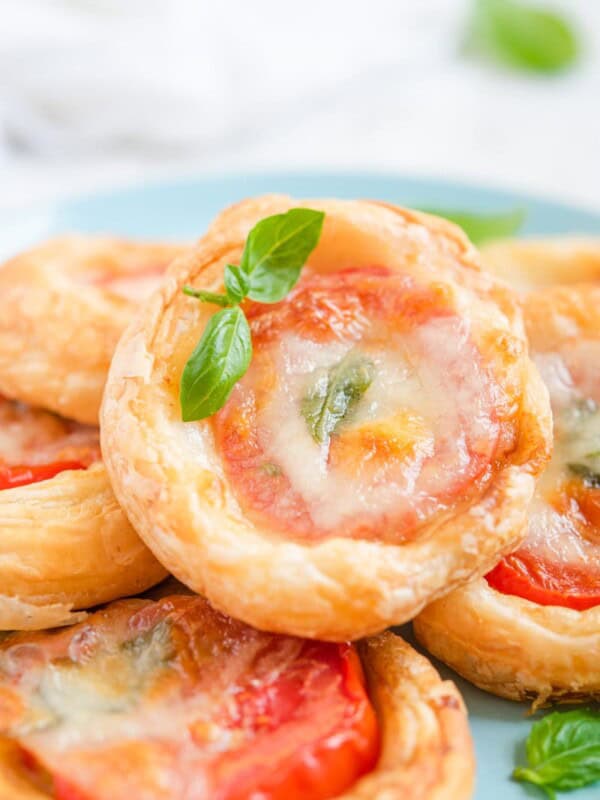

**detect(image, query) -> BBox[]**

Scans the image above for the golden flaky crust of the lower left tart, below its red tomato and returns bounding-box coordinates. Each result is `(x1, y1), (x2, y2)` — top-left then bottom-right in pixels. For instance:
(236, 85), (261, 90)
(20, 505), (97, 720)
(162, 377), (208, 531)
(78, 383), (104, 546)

(0, 463), (166, 630)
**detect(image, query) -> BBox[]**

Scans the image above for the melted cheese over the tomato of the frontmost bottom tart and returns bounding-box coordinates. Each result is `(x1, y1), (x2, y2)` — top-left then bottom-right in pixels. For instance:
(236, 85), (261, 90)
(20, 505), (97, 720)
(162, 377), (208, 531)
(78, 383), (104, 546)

(0, 611), (303, 763)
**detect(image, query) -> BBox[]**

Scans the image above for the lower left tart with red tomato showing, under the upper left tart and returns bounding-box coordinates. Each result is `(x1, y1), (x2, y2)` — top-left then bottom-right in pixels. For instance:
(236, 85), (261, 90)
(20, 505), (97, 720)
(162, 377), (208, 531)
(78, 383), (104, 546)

(0, 397), (165, 632)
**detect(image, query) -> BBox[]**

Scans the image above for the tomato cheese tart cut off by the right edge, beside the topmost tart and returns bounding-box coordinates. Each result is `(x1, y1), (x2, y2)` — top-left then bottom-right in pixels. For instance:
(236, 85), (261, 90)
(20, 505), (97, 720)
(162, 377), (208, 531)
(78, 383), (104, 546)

(415, 285), (600, 703)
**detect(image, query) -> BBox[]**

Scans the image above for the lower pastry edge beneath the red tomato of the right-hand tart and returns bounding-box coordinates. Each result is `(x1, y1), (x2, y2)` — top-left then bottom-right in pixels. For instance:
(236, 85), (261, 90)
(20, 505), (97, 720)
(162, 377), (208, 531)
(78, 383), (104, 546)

(413, 578), (600, 706)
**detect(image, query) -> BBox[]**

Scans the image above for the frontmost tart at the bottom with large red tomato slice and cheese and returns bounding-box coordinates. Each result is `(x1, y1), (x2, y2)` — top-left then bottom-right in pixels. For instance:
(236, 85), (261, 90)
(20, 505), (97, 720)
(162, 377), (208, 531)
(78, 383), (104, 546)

(0, 595), (473, 800)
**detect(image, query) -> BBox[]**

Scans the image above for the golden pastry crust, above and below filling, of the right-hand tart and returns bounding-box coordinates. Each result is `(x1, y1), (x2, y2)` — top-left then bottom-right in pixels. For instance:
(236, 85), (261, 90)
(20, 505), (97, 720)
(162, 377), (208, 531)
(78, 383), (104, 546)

(414, 284), (600, 705)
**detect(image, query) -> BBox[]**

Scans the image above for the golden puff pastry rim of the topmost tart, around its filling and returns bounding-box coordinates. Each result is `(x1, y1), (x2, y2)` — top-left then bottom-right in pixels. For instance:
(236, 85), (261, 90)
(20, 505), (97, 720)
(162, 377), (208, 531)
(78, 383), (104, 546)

(102, 196), (550, 640)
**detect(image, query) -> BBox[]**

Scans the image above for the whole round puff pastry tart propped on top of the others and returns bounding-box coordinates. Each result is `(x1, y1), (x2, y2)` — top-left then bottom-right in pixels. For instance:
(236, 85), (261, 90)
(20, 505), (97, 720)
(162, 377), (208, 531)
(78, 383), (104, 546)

(102, 197), (550, 640)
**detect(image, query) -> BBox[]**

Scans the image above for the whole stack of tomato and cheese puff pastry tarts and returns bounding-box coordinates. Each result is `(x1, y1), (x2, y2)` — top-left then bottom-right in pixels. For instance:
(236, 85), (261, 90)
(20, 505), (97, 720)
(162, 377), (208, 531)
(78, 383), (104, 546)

(0, 196), (600, 800)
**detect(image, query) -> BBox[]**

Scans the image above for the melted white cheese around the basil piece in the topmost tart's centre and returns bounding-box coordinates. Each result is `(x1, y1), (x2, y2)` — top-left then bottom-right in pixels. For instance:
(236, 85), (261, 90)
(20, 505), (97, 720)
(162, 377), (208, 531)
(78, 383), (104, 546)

(258, 318), (497, 529)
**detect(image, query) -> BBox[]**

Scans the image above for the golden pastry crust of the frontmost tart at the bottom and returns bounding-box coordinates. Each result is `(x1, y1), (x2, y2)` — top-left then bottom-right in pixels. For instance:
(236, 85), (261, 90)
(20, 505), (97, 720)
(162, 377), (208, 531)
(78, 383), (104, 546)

(0, 632), (475, 800)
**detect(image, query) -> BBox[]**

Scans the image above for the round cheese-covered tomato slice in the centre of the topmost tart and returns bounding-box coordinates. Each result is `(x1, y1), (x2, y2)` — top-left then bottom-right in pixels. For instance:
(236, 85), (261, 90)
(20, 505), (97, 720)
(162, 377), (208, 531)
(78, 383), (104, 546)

(213, 267), (501, 542)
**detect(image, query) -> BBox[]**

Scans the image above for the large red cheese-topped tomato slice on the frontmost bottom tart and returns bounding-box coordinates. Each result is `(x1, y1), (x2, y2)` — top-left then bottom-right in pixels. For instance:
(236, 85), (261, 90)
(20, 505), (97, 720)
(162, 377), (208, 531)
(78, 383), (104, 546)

(0, 596), (379, 800)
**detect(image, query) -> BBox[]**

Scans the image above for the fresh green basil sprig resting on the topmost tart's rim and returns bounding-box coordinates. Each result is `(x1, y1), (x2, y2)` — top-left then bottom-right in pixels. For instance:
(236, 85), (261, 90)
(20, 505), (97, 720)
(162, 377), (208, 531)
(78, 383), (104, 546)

(180, 208), (325, 422)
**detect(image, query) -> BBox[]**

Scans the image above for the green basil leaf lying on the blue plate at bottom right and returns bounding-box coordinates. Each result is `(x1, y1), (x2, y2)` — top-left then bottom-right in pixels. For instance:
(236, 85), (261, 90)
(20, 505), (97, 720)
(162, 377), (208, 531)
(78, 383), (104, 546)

(513, 709), (600, 797)
